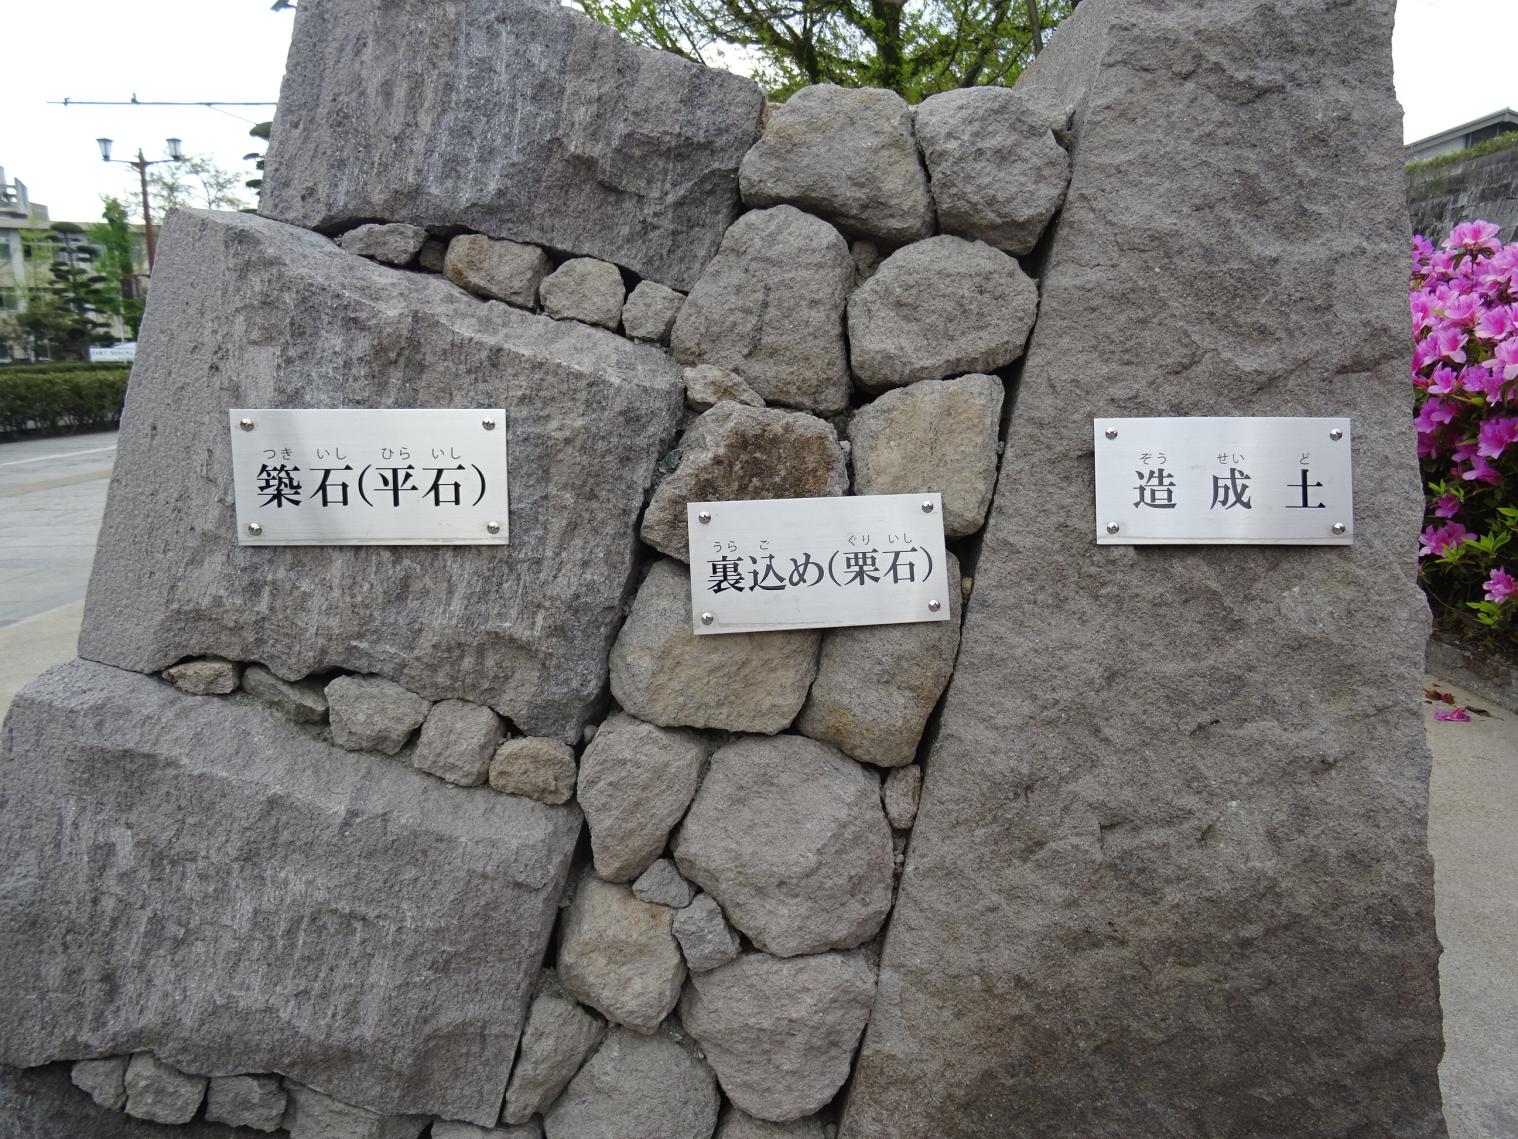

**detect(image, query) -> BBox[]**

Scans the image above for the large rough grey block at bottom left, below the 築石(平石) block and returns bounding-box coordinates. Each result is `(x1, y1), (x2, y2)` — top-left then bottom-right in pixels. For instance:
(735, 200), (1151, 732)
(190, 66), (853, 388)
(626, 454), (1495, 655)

(0, 661), (580, 1122)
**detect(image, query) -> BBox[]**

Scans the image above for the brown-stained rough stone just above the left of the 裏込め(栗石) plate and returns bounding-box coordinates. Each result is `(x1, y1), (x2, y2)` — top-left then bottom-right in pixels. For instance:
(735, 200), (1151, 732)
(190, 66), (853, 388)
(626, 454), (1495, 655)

(642, 401), (849, 562)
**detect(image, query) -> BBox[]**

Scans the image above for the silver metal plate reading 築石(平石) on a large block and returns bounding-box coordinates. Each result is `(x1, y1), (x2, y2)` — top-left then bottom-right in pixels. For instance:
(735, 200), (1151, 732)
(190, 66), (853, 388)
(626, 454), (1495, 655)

(228, 407), (507, 545)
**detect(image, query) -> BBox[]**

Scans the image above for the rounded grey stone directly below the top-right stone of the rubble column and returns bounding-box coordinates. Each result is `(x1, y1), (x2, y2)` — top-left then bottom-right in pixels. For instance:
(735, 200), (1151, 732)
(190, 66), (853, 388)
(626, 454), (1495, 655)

(849, 237), (1038, 392)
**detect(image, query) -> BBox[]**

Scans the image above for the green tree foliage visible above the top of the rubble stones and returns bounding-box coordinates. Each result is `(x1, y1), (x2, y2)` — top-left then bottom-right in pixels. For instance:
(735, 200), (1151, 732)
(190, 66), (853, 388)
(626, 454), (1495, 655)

(575, 0), (1078, 103)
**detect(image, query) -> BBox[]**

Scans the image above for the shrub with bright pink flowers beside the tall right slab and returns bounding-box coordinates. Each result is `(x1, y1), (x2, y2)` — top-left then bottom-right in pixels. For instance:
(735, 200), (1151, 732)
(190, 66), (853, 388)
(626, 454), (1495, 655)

(1409, 222), (1518, 648)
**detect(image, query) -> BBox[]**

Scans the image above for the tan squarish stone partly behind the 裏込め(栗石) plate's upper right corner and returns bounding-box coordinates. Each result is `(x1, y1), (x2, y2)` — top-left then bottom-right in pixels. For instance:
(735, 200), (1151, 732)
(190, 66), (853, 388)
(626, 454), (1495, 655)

(849, 375), (1002, 538)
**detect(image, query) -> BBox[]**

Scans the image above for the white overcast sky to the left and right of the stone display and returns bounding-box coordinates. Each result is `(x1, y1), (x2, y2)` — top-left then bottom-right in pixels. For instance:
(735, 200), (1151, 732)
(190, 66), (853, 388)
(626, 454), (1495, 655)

(0, 0), (1518, 222)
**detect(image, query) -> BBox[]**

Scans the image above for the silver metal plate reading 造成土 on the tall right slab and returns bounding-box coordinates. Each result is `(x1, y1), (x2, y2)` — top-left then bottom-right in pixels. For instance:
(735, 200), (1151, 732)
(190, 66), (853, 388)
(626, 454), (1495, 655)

(1093, 416), (1354, 545)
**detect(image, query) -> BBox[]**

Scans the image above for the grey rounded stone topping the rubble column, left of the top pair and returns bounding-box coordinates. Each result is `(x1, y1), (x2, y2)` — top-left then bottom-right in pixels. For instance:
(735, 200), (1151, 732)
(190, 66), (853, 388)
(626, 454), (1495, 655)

(738, 84), (934, 245)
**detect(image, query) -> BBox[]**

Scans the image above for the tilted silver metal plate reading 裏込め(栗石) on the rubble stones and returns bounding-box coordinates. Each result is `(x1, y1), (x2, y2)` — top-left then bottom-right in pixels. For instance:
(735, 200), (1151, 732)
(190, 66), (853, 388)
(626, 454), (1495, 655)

(686, 494), (959, 633)
